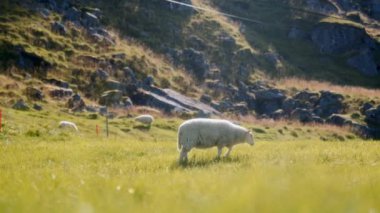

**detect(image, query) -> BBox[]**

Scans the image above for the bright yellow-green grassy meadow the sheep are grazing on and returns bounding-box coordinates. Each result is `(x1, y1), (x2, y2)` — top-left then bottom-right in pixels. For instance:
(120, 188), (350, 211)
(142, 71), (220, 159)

(0, 106), (380, 212)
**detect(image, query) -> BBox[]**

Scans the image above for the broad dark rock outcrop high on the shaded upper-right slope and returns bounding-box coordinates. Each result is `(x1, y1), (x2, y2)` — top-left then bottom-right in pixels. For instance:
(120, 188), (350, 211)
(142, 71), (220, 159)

(311, 24), (371, 54)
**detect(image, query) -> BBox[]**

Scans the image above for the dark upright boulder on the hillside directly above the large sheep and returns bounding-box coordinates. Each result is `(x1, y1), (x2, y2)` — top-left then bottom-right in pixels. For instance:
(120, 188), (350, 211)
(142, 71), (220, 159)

(181, 48), (210, 80)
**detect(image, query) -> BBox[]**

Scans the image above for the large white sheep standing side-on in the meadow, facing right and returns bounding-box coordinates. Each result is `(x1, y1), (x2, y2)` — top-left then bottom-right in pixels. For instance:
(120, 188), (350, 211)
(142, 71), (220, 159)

(178, 118), (254, 162)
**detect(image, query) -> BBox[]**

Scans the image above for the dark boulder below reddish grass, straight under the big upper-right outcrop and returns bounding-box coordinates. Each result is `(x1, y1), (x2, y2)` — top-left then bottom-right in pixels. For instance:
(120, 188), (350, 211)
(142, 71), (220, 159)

(314, 91), (344, 118)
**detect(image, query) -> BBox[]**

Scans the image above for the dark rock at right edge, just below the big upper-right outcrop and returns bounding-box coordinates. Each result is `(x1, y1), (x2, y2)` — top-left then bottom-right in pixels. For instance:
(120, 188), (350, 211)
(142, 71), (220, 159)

(347, 50), (380, 76)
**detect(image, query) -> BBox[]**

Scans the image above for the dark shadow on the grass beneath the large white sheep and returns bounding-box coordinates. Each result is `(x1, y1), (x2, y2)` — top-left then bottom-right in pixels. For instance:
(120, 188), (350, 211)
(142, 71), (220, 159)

(171, 156), (245, 169)
